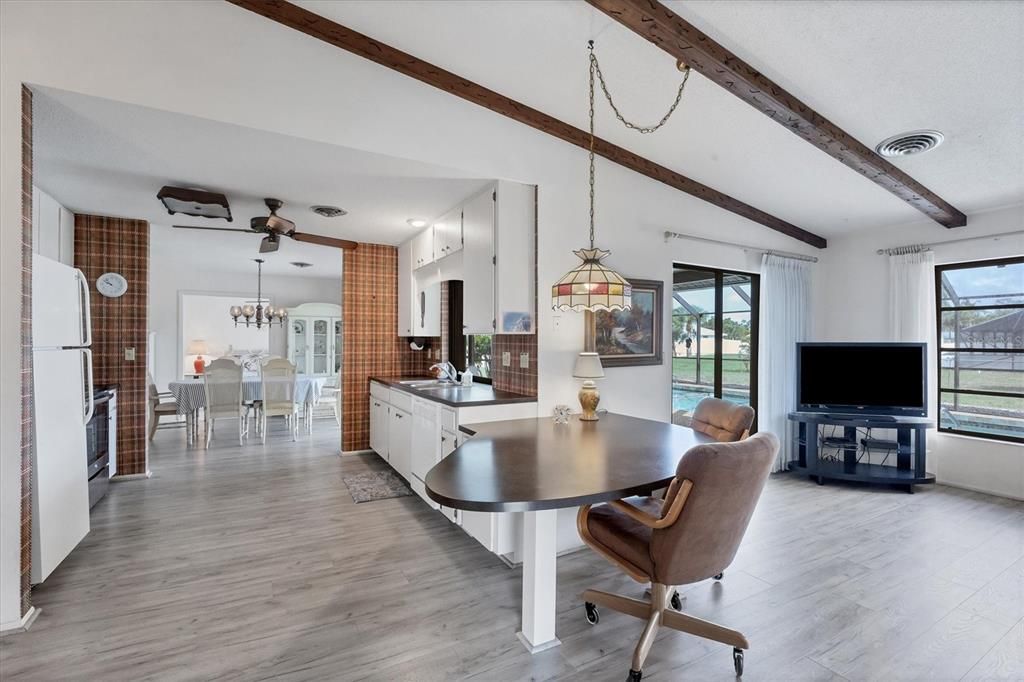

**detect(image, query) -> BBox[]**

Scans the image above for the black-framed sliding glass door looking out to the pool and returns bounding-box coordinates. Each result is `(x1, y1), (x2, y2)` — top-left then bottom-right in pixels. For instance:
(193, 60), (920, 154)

(672, 265), (758, 421)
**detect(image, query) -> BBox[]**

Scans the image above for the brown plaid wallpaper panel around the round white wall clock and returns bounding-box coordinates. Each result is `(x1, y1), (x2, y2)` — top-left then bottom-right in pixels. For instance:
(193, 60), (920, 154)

(75, 215), (150, 476)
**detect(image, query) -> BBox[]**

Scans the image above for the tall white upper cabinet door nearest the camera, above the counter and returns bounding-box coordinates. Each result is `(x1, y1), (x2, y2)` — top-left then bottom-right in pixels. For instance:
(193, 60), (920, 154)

(462, 188), (495, 335)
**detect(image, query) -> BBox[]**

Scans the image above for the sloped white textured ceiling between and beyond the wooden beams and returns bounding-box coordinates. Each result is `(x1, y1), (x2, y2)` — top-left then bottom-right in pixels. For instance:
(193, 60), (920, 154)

(300, 0), (1024, 237)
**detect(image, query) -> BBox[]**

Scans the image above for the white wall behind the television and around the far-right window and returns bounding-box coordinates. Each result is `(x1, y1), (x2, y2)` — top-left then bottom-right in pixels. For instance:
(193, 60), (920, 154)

(814, 207), (1024, 499)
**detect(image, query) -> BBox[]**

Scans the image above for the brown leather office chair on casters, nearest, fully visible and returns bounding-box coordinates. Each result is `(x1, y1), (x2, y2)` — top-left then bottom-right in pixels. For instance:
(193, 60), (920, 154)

(577, 433), (778, 682)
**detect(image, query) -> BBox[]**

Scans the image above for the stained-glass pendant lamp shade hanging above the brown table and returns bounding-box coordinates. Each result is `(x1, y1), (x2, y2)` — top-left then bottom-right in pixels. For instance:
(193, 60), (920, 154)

(551, 249), (633, 311)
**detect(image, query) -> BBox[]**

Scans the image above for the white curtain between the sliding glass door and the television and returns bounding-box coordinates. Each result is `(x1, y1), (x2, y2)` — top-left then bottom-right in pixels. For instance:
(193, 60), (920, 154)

(758, 254), (811, 471)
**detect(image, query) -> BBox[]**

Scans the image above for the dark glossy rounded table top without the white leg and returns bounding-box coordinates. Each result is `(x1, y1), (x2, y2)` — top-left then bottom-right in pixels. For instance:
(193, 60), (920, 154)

(425, 413), (715, 511)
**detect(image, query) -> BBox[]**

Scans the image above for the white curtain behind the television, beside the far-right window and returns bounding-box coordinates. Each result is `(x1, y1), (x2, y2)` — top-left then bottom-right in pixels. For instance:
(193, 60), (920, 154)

(889, 251), (937, 417)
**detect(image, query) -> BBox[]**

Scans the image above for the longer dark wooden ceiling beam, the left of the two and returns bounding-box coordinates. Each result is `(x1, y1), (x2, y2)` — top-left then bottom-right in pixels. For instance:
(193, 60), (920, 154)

(227, 0), (827, 249)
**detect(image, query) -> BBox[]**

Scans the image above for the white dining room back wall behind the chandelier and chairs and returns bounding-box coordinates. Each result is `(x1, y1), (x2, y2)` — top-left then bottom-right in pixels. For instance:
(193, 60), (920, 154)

(150, 226), (342, 390)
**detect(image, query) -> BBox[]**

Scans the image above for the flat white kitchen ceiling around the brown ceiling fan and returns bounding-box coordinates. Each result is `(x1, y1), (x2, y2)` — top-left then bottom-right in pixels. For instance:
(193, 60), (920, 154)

(33, 88), (488, 274)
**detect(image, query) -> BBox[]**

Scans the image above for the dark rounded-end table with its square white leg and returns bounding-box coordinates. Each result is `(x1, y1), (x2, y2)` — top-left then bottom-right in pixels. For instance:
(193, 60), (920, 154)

(425, 413), (714, 653)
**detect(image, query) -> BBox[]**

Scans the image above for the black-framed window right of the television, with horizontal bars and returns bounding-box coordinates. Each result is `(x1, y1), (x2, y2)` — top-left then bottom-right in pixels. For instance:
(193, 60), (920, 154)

(935, 257), (1024, 442)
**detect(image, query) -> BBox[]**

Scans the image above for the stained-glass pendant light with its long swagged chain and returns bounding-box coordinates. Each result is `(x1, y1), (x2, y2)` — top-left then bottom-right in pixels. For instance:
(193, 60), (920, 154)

(551, 40), (690, 312)
